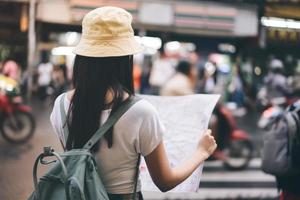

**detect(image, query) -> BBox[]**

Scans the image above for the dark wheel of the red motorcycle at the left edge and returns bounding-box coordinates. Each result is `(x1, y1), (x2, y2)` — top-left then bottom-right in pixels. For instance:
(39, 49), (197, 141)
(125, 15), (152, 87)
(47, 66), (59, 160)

(0, 111), (35, 144)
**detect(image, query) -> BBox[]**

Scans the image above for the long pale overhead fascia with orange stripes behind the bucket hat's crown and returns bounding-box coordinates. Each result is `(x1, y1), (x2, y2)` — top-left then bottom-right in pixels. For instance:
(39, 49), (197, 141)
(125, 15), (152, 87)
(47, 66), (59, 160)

(38, 0), (258, 37)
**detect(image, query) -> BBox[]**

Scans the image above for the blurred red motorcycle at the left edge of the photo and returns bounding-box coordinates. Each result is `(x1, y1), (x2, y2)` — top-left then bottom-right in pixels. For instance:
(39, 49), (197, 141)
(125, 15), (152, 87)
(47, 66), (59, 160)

(0, 76), (35, 143)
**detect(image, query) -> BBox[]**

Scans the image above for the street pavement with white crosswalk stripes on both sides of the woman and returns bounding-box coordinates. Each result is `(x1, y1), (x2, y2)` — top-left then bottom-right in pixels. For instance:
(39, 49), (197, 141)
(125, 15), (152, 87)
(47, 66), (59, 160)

(0, 98), (277, 200)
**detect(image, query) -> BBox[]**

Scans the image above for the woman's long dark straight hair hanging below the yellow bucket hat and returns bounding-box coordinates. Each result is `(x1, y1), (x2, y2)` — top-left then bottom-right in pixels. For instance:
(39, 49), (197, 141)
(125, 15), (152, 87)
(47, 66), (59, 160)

(65, 55), (134, 151)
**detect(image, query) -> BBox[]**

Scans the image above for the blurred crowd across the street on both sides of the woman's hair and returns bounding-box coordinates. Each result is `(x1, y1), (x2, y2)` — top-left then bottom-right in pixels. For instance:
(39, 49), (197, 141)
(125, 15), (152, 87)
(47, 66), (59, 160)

(0, 48), (300, 111)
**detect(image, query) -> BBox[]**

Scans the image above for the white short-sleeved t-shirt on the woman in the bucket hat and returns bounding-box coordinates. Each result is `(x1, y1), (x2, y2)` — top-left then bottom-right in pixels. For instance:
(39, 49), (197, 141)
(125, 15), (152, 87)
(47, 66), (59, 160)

(50, 95), (165, 194)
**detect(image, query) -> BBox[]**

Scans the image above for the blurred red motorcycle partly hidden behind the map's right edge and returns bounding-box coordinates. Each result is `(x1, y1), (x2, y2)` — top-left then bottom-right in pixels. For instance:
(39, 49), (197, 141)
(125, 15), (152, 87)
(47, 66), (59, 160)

(211, 105), (253, 170)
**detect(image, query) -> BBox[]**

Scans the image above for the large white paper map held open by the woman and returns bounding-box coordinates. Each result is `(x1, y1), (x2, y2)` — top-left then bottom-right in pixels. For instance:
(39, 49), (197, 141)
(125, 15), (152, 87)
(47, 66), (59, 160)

(140, 94), (220, 192)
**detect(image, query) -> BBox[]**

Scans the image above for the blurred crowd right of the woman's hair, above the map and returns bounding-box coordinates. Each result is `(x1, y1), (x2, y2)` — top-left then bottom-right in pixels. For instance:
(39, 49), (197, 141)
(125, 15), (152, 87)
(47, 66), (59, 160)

(134, 52), (300, 115)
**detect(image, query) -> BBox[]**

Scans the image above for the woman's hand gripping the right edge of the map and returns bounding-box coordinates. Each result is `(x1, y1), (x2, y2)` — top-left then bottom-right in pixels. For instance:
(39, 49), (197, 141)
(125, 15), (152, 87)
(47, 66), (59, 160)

(197, 129), (217, 159)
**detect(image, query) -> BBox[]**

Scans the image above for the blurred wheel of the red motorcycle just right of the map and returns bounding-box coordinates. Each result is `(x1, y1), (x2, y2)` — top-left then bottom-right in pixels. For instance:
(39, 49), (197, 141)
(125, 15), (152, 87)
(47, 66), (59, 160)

(223, 140), (253, 170)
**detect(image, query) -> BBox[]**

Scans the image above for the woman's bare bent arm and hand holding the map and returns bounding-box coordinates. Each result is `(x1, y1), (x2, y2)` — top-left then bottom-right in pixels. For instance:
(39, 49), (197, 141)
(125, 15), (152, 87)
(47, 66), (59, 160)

(145, 130), (217, 192)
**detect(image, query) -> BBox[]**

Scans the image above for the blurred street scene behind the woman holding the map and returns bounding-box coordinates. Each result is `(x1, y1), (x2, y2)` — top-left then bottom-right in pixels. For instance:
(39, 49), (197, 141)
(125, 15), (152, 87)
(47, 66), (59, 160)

(0, 0), (300, 200)
